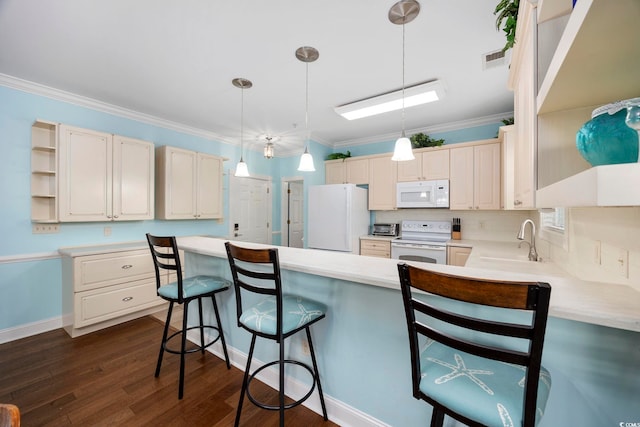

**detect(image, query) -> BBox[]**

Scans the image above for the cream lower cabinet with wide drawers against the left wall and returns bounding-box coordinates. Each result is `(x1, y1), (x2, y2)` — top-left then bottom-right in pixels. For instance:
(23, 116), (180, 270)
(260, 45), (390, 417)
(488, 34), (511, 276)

(60, 247), (169, 337)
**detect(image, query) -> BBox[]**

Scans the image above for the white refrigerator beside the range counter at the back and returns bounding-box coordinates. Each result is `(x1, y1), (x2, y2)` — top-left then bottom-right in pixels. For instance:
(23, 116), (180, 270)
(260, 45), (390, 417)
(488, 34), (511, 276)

(307, 184), (370, 254)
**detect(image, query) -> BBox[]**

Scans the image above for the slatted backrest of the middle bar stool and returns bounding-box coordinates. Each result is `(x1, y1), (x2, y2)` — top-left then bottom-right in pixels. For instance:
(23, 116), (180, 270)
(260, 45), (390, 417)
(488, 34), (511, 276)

(225, 242), (282, 339)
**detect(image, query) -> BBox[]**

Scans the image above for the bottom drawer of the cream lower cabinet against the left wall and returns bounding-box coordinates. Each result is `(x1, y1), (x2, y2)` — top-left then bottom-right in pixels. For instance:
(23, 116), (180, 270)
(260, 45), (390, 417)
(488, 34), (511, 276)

(74, 279), (165, 328)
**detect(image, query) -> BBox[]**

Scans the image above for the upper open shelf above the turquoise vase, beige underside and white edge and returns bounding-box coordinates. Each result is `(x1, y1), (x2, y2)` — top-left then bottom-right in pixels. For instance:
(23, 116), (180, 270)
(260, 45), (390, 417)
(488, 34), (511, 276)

(538, 0), (640, 114)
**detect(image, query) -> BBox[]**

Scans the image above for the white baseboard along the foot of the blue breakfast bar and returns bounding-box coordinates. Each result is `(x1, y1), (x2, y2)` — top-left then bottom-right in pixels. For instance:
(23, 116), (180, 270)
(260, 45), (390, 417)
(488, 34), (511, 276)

(188, 331), (391, 427)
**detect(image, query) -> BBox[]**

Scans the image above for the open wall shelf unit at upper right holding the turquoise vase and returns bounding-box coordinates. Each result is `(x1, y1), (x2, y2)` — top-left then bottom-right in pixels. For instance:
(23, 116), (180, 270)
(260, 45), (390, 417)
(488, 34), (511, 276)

(536, 0), (640, 208)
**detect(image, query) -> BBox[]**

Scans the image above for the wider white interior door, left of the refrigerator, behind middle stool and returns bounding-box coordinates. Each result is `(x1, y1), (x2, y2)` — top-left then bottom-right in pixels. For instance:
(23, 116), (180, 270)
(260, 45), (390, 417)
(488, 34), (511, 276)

(229, 173), (271, 244)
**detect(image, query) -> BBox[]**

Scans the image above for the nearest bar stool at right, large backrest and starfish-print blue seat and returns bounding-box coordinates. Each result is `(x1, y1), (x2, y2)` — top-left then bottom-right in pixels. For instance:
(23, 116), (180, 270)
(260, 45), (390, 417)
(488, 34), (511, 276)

(398, 263), (551, 427)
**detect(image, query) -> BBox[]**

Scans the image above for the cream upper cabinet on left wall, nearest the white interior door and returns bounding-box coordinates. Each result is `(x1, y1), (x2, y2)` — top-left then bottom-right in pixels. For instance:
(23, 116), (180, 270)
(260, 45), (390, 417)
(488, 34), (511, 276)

(156, 146), (223, 219)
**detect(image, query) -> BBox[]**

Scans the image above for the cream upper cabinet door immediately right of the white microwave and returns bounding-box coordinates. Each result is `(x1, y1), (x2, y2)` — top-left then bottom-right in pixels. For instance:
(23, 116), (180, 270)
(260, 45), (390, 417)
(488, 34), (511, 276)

(449, 147), (474, 210)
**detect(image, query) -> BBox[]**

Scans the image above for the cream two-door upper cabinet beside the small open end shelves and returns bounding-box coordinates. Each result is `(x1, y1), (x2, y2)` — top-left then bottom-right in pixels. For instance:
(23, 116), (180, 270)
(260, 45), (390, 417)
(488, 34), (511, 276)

(59, 125), (154, 222)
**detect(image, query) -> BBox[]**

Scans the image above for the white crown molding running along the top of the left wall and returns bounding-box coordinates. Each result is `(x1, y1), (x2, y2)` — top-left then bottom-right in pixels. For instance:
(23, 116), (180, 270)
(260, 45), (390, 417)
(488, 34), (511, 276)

(0, 73), (239, 145)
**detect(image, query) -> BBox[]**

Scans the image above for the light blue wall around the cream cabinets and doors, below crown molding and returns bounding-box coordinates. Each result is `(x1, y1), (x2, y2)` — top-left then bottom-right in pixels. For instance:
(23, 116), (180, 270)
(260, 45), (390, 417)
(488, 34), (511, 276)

(0, 86), (500, 331)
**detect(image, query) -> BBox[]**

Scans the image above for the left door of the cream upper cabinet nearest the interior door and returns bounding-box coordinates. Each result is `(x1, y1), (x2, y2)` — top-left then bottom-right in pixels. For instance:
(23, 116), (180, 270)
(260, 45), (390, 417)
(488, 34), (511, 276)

(157, 146), (198, 219)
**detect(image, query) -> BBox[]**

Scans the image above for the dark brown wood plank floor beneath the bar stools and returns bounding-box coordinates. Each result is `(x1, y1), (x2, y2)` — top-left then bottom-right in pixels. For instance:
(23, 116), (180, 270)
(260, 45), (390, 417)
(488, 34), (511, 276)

(0, 317), (336, 427)
